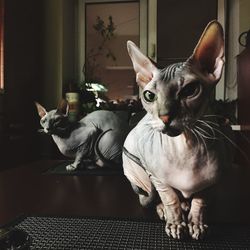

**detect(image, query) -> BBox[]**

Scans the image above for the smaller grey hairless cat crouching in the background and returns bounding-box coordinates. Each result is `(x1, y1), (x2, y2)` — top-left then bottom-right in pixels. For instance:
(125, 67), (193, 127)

(36, 102), (129, 171)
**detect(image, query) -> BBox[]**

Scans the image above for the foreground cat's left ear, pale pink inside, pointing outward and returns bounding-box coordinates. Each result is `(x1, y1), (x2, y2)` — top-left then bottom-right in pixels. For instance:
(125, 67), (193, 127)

(127, 41), (157, 88)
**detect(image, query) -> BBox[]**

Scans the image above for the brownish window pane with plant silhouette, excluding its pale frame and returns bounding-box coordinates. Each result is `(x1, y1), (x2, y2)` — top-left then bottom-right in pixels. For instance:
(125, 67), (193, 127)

(83, 1), (140, 102)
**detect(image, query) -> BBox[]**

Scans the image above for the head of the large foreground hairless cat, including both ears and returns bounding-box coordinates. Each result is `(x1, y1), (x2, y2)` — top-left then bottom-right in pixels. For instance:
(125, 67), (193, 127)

(127, 21), (224, 136)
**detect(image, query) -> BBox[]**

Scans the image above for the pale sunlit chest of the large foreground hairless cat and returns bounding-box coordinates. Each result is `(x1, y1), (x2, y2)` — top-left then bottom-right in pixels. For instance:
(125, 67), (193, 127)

(139, 129), (219, 197)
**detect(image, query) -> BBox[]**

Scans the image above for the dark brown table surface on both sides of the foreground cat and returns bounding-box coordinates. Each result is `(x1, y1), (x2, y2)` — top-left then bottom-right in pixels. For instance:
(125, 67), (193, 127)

(0, 160), (250, 228)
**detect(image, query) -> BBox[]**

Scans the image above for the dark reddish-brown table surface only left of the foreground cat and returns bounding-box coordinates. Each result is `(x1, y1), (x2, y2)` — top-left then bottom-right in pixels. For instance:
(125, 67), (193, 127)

(0, 160), (153, 225)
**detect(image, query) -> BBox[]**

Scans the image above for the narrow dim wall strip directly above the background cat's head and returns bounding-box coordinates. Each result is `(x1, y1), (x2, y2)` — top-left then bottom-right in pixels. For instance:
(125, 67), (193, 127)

(41, 0), (63, 109)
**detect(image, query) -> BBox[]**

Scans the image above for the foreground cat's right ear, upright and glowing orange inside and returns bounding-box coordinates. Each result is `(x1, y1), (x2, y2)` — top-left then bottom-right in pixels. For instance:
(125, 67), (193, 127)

(190, 20), (224, 83)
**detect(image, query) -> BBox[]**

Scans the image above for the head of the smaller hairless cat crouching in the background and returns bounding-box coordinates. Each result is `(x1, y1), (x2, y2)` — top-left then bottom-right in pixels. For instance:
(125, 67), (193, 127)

(35, 101), (69, 135)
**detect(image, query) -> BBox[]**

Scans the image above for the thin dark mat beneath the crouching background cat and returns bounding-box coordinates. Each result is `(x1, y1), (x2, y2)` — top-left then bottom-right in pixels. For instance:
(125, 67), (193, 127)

(44, 161), (123, 175)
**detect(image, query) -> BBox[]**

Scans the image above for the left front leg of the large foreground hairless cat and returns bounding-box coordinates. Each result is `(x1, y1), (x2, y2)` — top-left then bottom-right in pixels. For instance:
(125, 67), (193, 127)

(158, 186), (187, 239)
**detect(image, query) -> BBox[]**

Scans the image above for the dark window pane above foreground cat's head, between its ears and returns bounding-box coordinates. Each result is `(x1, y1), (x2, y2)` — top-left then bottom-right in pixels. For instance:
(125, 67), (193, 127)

(157, 0), (217, 67)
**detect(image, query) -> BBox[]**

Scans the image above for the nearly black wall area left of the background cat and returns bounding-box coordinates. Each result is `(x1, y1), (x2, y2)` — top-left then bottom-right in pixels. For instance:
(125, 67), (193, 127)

(1, 0), (42, 165)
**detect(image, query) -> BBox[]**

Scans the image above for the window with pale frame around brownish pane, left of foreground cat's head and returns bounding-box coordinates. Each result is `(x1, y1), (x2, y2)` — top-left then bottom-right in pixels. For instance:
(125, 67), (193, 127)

(76, 0), (148, 100)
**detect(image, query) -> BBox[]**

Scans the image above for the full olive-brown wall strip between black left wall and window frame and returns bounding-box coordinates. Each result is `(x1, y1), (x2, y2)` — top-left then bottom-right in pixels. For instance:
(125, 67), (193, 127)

(41, 0), (76, 109)
